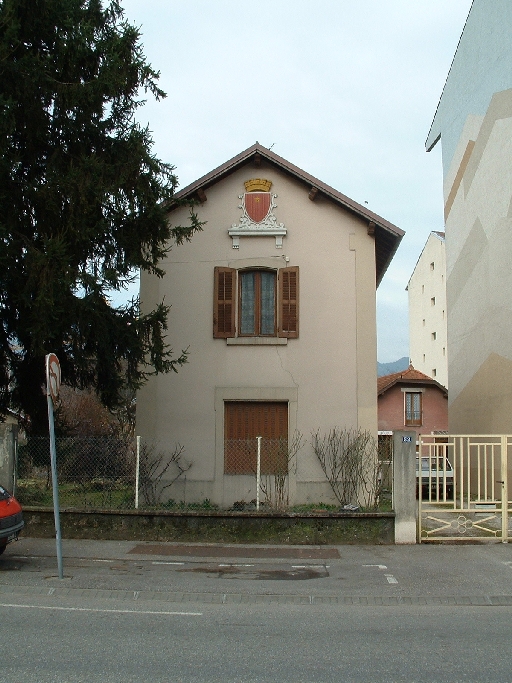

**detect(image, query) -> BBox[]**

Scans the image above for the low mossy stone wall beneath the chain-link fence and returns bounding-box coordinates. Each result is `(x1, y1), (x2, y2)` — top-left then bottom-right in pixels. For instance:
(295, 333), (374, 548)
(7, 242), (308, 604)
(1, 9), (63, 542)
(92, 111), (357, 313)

(23, 506), (395, 545)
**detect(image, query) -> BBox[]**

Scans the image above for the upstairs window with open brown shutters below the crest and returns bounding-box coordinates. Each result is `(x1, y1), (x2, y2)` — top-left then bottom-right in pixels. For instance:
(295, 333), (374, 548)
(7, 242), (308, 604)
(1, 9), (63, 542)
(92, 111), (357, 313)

(213, 266), (299, 339)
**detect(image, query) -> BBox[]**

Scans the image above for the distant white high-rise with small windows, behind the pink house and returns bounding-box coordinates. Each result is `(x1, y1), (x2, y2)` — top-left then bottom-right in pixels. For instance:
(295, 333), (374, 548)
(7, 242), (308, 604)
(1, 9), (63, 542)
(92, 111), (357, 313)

(407, 232), (448, 387)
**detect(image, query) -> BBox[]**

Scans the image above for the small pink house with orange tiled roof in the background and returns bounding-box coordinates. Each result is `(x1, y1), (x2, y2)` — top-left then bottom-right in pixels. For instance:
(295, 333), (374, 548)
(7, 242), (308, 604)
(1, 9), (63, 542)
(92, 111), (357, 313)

(377, 364), (448, 452)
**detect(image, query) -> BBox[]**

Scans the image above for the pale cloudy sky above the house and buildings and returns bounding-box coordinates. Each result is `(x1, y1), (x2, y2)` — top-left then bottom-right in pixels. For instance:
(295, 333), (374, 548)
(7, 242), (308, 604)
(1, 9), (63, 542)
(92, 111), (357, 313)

(121, 0), (471, 363)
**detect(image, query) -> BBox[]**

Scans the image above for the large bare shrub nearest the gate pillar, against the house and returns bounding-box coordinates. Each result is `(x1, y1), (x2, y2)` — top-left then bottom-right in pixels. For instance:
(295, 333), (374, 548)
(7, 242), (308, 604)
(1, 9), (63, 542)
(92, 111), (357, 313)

(312, 427), (381, 509)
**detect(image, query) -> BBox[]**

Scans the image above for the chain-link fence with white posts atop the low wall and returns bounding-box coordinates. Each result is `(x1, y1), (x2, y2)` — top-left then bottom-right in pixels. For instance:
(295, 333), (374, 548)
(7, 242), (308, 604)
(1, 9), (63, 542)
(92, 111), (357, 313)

(16, 433), (392, 511)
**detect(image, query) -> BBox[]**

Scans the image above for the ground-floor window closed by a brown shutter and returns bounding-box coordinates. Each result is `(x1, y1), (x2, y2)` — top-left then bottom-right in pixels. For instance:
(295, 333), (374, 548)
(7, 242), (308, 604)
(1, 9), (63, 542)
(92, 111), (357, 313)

(224, 401), (288, 475)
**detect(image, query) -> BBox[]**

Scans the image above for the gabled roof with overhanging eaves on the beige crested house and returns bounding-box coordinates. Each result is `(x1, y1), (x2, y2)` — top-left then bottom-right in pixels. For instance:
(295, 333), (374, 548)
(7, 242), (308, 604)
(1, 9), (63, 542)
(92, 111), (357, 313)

(171, 142), (405, 285)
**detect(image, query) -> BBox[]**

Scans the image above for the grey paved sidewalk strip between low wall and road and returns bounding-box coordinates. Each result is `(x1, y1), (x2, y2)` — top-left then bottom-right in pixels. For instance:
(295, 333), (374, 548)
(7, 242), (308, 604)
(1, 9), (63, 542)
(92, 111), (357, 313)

(0, 537), (512, 607)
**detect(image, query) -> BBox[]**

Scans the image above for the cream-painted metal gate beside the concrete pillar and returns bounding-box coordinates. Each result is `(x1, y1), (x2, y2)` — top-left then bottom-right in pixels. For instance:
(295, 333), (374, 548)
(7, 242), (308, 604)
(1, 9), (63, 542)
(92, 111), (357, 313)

(416, 434), (512, 543)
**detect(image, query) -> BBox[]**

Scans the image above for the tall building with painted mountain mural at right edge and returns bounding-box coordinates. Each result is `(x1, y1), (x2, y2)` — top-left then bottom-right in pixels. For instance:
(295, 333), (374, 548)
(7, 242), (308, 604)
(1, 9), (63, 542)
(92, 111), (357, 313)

(426, 0), (512, 434)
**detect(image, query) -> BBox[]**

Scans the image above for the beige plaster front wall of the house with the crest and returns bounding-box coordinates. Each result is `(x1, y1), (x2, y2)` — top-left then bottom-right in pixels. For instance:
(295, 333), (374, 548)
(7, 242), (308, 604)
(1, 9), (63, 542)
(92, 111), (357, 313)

(137, 163), (377, 506)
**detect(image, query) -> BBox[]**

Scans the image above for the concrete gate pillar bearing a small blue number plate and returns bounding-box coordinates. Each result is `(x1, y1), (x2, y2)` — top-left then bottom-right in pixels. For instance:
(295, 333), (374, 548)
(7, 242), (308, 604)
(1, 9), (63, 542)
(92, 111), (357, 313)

(393, 431), (417, 544)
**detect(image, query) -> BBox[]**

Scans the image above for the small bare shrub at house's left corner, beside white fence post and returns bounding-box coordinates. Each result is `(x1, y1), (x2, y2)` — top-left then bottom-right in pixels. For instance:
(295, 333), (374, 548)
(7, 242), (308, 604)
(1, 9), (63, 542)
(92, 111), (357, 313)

(139, 444), (192, 507)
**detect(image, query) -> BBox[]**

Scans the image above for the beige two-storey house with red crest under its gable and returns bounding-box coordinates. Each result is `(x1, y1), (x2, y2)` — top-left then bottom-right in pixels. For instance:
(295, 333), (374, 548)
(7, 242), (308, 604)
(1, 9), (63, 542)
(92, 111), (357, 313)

(137, 143), (403, 506)
